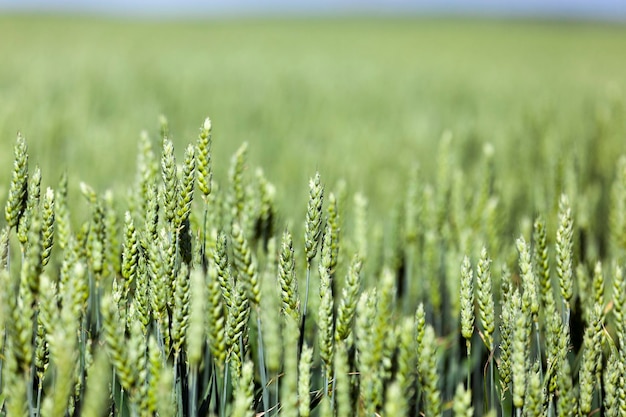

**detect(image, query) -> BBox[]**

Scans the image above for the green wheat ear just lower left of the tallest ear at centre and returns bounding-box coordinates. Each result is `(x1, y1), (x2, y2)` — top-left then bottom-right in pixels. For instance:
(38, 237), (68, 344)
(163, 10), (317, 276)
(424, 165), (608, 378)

(278, 230), (300, 320)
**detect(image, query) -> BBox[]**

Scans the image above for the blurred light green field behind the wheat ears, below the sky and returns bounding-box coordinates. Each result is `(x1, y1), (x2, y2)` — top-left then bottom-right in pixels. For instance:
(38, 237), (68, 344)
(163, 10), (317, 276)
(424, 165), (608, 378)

(0, 16), (626, 226)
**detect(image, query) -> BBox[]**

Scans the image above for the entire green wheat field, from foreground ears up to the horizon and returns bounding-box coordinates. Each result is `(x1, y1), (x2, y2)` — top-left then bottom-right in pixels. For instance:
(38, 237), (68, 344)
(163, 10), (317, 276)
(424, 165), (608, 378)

(0, 14), (626, 417)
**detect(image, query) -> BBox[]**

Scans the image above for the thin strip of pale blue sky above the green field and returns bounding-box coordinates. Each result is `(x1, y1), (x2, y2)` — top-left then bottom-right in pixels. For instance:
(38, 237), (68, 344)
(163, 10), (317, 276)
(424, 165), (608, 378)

(0, 0), (626, 20)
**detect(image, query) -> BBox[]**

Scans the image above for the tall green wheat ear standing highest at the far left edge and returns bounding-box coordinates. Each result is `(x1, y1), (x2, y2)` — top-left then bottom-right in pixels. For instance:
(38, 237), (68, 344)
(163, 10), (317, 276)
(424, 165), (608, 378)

(4, 133), (28, 228)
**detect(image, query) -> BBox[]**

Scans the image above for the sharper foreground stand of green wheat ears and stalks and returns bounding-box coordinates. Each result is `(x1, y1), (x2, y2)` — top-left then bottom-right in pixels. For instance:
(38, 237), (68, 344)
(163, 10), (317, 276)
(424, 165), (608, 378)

(0, 115), (626, 417)
